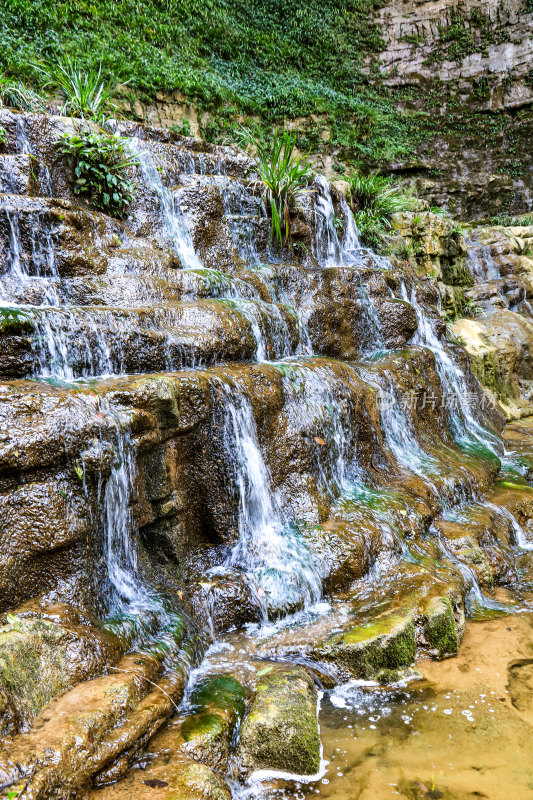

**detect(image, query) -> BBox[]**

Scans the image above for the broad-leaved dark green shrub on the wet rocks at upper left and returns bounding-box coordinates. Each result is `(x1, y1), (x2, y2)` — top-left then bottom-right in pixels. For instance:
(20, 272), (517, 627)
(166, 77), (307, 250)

(56, 129), (139, 217)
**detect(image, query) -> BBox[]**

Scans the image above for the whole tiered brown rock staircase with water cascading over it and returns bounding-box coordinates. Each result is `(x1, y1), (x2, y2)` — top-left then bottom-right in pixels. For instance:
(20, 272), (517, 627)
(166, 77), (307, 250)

(0, 110), (533, 798)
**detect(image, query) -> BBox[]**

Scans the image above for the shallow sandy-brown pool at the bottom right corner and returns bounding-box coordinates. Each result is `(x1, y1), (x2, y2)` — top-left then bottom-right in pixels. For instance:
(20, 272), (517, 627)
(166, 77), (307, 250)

(242, 613), (533, 800)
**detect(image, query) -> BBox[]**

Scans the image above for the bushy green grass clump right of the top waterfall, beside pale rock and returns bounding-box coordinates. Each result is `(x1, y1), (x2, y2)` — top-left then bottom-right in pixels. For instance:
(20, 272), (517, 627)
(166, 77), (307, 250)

(348, 174), (416, 250)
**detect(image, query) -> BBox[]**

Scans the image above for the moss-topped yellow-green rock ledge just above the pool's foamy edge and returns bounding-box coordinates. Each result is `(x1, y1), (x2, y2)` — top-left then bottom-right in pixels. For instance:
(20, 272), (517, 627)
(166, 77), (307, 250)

(314, 613), (416, 682)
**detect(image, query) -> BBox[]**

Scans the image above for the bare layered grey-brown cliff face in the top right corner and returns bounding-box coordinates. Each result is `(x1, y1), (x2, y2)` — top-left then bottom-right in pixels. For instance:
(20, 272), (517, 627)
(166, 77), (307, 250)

(377, 0), (533, 219)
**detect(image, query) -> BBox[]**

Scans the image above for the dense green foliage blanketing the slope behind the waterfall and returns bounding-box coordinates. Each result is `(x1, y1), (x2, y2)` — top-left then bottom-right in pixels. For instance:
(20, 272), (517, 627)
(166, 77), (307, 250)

(0, 0), (426, 160)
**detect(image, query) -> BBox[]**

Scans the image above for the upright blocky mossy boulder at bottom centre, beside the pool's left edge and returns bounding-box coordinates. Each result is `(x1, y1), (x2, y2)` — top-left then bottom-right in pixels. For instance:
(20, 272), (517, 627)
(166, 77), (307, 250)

(238, 667), (320, 775)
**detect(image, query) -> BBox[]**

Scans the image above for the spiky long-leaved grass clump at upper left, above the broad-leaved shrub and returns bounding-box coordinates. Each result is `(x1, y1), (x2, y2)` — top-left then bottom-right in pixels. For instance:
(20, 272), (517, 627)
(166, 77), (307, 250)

(34, 56), (115, 120)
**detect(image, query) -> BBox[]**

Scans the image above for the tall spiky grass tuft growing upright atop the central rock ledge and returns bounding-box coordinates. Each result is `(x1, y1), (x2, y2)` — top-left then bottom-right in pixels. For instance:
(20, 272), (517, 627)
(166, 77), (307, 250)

(246, 128), (313, 248)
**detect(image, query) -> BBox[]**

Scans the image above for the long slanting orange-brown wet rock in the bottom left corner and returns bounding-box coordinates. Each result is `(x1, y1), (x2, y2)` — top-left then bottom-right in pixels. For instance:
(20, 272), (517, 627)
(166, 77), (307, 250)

(0, 653), (185, 800)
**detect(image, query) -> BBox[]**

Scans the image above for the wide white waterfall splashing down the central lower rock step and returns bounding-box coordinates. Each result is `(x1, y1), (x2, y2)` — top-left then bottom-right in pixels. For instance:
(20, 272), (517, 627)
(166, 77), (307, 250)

(218, 382), (321, 620)
